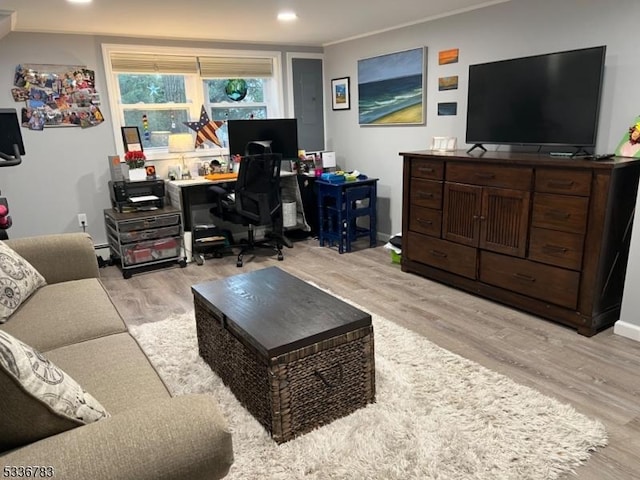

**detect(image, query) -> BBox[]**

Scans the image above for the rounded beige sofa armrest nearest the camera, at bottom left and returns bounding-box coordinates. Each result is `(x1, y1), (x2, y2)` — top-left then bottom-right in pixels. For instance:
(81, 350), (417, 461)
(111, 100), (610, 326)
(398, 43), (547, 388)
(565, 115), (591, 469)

(0, 395), (233, 480)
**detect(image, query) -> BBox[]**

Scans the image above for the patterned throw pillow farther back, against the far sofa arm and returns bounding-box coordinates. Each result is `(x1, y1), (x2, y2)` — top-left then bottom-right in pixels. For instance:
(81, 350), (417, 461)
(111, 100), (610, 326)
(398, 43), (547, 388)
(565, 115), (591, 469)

(0, 241), (47, 323)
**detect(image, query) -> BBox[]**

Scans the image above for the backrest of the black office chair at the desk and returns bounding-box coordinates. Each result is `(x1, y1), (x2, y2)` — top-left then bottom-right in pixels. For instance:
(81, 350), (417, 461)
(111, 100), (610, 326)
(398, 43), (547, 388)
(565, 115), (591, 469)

(235, 153), (282, 225)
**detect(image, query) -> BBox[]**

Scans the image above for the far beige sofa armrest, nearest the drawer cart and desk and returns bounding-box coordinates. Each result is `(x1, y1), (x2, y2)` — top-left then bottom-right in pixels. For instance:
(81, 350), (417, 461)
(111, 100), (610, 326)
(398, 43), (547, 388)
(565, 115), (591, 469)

(5, 233), (100, 284)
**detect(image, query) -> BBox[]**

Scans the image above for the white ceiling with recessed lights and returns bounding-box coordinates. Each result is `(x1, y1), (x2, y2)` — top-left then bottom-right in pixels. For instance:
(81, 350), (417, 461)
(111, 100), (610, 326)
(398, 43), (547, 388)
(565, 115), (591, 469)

(0, 0), (508, 46)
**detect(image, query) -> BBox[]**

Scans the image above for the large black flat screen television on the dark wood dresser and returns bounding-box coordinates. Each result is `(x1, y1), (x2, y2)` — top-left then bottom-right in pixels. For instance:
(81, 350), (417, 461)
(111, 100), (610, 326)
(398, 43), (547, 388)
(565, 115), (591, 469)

(466, 46), (606, 149)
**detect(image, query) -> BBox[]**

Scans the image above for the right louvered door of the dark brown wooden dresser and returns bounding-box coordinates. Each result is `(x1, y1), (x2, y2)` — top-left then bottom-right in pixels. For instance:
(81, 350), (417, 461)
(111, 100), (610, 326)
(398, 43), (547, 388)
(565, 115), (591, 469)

(479, 187), (530, 257)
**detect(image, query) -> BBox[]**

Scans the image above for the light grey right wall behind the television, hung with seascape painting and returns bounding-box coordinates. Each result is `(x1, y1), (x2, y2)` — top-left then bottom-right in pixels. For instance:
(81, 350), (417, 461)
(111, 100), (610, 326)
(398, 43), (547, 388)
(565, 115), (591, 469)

(325, 0), (640, 339)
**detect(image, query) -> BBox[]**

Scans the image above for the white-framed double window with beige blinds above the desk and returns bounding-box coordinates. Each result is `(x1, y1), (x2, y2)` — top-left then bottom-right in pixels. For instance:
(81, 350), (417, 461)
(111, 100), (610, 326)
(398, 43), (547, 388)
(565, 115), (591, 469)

(103, 45), (283, 158)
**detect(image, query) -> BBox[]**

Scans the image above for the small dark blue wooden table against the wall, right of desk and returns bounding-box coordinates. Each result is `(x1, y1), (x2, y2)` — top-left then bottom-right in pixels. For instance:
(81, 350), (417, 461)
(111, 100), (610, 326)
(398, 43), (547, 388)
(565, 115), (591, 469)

(316, 178), (378, 253)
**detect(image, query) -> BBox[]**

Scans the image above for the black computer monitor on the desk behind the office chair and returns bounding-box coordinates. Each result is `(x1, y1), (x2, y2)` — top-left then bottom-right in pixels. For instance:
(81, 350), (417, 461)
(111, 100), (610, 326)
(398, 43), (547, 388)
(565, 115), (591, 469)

(227, 118), (298, 160)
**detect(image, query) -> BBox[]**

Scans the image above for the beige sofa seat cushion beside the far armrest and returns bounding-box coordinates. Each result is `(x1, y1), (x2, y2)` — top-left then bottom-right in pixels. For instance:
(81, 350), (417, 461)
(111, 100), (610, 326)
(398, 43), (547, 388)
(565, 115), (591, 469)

(1, 278), (127, 352)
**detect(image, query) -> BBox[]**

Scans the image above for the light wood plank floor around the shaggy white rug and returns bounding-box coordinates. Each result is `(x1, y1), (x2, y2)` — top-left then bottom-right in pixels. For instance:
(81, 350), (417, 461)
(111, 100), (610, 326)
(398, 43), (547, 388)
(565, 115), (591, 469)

(101, 239), (640, 480)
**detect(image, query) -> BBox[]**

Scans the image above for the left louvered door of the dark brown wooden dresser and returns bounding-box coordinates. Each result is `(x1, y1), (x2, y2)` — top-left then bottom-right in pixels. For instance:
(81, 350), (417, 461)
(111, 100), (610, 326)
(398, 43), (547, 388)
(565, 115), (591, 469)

(442, 182), (482, 247)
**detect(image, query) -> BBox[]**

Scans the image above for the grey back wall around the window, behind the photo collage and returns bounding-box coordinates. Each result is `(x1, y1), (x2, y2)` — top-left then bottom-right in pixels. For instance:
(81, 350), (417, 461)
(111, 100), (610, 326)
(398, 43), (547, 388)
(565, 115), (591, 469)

(0, 32), (321, 244)
